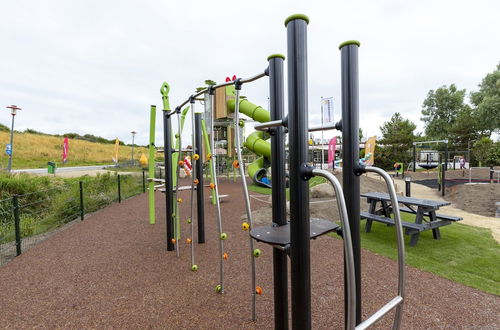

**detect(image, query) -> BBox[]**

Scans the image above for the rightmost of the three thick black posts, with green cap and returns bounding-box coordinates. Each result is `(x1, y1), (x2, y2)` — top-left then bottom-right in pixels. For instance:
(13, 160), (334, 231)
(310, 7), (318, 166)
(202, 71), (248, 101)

(339, 41), (361, 324)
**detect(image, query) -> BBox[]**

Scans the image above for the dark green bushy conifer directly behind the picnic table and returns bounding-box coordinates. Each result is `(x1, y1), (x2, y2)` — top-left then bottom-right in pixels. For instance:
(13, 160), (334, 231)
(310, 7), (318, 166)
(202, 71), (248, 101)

(375, 112), (417, 168)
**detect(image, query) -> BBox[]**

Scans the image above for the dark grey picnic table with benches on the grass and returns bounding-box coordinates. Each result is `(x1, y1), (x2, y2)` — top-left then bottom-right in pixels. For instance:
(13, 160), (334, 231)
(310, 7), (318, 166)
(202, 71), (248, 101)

(360, 192), (462, 246)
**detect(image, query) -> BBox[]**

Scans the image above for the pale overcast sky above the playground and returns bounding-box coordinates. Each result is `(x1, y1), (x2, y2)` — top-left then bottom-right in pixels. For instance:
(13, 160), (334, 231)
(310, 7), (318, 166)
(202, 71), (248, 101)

(0, 0), (500, 145)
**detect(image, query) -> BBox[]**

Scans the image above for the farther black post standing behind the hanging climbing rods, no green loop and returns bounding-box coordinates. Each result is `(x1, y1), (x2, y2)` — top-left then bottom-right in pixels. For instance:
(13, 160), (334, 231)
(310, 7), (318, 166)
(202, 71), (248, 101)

(193, 113), (205, 244)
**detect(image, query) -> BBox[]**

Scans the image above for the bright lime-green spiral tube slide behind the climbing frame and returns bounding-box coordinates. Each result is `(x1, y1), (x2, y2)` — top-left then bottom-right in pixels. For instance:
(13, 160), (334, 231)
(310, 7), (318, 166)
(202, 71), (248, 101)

(227, 99), (271, 188)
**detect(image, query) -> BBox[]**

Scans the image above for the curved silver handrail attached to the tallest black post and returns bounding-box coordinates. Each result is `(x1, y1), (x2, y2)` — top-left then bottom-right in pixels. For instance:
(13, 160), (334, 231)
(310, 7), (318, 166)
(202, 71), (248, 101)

(312, 169), (356, 330)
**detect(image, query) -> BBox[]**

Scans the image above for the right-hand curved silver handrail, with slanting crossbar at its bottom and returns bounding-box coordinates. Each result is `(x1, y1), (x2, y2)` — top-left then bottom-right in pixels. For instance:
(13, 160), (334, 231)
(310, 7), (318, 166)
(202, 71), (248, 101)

(356, 167), (405, 330)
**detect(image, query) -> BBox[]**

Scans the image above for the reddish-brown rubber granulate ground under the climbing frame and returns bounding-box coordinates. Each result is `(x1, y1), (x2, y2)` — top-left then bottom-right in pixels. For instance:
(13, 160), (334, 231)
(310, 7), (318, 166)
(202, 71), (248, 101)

(0, 182), (500, 329)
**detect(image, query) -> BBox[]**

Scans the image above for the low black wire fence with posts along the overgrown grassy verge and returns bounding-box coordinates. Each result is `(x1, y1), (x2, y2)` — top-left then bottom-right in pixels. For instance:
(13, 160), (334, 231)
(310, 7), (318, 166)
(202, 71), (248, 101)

(0, 171), (147, 266)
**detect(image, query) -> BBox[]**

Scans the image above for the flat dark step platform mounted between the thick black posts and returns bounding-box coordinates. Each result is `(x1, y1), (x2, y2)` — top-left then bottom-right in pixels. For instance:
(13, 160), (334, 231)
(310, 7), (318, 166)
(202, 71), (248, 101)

(250, 218), (340, 246)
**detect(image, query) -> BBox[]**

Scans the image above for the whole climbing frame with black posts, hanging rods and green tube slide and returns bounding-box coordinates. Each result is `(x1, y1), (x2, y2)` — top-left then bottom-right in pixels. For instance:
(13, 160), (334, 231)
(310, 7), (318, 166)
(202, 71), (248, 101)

(149, 15), (405, 329)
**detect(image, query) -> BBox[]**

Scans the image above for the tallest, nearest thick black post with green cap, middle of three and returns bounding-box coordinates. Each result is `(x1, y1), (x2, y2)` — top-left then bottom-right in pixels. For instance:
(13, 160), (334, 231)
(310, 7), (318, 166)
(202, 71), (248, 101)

(285, 15), (311, 330)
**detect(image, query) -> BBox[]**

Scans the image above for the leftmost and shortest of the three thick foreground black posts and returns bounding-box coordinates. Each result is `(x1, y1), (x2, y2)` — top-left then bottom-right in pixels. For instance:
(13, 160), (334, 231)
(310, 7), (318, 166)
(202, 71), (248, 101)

(267, 54), (288, 329)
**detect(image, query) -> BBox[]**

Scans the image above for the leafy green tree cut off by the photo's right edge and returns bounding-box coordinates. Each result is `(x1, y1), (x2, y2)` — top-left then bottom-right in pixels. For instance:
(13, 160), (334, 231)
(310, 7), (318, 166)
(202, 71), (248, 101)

(470, 63), (500, 137)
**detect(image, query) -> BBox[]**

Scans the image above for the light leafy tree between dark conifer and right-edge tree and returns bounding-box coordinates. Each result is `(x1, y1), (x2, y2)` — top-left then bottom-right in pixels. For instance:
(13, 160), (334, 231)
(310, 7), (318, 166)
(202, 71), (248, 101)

(421, 84), (467, 140)
